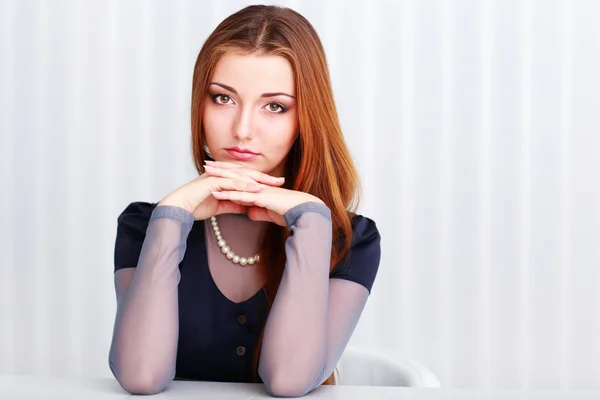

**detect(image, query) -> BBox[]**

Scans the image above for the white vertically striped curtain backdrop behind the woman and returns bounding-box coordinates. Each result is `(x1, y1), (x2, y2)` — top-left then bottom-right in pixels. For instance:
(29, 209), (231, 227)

(0, 0), (600, 389)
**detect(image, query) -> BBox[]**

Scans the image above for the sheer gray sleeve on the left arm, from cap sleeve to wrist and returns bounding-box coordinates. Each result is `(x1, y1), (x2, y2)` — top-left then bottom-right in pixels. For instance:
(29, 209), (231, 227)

(109, 206), (194, 394)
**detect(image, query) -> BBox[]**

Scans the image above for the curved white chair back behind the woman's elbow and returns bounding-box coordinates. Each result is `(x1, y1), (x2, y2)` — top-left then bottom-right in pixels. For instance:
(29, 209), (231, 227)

(336, 346), (441, 388)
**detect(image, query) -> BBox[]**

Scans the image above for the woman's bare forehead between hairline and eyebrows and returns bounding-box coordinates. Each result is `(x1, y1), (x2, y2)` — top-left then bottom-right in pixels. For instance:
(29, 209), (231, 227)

(212, 51), (296, 96)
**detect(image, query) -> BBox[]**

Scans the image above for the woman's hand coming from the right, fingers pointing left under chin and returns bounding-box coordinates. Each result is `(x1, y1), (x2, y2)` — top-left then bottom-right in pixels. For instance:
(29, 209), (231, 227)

(206, 161), (325, 226)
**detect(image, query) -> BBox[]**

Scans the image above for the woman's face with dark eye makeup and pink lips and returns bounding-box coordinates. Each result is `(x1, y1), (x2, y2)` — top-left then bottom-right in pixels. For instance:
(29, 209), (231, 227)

(203, 52), (298, 176)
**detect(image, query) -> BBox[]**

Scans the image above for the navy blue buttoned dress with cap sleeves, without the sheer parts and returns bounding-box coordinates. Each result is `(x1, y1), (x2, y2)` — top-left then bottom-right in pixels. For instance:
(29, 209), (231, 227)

(114, 202), (380, 382)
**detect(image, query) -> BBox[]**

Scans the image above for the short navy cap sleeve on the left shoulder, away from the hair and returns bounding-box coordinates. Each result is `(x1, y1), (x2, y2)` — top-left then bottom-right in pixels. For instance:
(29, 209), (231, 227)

(114, 202), (157, 271)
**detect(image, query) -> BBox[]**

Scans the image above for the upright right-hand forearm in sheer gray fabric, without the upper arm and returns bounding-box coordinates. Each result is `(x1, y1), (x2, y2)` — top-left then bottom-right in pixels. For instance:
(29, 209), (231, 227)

(259, 208), (331, 396)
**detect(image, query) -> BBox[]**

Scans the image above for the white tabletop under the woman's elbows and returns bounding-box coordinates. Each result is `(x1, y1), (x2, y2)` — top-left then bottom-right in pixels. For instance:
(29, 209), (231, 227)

(0, 374), (600, 400)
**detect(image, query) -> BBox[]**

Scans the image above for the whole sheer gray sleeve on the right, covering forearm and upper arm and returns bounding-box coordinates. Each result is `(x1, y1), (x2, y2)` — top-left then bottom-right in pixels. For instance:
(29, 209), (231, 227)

(259, 202), (370, 397)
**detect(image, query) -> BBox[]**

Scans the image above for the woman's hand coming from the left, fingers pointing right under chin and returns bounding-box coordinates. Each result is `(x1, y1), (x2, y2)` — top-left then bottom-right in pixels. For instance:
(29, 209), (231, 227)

(158, 166), (283, 220)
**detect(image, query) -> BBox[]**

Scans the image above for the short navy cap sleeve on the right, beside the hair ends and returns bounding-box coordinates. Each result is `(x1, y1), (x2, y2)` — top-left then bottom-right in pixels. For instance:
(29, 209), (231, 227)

(330, 214), (381, 292)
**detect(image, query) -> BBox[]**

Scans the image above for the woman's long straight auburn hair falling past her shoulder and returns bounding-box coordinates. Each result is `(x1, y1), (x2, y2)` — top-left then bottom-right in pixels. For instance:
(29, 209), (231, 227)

(191, 5), (360, 384)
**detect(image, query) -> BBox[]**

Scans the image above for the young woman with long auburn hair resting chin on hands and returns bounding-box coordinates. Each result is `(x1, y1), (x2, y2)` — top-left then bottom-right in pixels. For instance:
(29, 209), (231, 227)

(109, 6), (380, 396)
